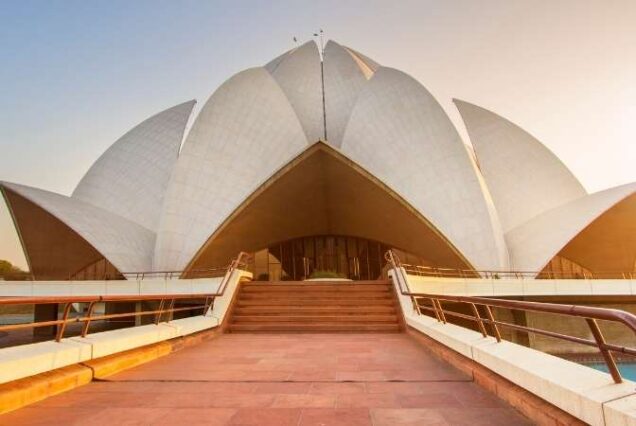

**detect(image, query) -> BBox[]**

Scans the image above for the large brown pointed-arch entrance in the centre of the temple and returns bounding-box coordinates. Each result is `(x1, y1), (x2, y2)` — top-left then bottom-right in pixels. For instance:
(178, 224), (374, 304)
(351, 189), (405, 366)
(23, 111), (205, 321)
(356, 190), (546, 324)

(183, 143), (471, 281)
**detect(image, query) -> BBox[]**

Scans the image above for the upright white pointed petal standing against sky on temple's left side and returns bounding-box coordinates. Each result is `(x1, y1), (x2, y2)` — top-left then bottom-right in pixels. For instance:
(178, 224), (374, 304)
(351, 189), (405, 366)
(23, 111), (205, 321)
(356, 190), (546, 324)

(72, 101), (195, 231)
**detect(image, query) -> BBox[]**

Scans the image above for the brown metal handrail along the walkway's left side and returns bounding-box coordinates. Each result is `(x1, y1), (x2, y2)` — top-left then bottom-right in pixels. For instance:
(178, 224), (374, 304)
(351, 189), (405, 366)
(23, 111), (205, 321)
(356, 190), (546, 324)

(0, 252), (248, 342)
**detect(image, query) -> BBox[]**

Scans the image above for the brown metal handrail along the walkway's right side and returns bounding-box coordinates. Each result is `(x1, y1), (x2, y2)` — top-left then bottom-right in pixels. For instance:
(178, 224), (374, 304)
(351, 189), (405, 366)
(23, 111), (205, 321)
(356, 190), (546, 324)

(385, 250), (636, 383)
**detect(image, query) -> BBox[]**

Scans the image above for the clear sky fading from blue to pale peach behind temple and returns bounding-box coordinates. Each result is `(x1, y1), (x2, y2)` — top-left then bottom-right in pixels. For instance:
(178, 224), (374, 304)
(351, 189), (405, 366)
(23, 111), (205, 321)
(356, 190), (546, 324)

(0, 0), (636, 268)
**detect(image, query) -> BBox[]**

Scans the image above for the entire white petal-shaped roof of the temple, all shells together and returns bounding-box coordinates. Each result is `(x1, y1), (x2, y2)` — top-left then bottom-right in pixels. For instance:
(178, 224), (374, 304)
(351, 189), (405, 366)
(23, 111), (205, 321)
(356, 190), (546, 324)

(3, 41), (636, 280)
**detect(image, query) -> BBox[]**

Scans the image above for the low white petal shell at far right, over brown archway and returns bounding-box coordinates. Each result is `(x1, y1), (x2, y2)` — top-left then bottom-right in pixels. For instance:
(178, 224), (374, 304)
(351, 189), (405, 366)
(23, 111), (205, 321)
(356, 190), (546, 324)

(506, 182), (636, 271)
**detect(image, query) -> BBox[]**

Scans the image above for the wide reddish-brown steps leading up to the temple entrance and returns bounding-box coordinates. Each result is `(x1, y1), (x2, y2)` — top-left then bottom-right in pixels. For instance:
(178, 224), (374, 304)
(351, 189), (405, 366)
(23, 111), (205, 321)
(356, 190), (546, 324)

(228, 281), (401, 333)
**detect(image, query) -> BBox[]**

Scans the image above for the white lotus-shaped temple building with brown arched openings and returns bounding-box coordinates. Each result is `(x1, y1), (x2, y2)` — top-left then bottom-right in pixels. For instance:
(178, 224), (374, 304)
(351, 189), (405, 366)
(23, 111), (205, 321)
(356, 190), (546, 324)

(1, 41), (636, 280)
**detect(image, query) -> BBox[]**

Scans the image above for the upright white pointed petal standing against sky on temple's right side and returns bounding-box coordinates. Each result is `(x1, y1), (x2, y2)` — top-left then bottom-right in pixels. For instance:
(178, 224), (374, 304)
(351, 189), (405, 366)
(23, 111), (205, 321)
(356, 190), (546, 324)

(454, 99), (587, 232)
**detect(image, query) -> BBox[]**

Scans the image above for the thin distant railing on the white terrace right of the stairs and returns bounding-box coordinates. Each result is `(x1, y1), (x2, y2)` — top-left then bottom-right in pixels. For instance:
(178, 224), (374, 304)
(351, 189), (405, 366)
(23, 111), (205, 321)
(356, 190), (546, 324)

(402, 263), (636, 279)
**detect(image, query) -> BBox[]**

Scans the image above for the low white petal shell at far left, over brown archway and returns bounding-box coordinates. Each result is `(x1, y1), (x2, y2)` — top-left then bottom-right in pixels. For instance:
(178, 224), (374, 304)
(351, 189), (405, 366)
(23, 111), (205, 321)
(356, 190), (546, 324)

(1, 182), (155, 272)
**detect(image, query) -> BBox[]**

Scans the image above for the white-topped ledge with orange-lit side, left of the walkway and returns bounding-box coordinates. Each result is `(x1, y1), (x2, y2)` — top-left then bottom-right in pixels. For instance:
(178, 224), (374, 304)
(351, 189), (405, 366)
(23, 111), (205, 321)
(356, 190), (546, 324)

(0, 271), (251, 414)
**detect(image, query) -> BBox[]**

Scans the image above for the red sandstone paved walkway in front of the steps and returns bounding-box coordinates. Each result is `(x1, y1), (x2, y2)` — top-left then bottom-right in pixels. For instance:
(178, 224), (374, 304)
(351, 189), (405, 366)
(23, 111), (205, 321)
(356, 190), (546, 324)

(0, 334), (529, 426)
